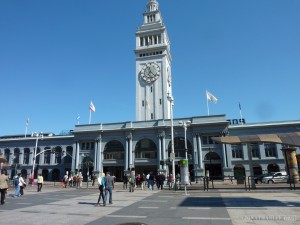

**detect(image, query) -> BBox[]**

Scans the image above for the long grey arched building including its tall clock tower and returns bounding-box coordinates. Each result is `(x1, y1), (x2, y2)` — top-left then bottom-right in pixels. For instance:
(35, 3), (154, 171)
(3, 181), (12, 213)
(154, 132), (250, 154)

(0, 0), (300, 180)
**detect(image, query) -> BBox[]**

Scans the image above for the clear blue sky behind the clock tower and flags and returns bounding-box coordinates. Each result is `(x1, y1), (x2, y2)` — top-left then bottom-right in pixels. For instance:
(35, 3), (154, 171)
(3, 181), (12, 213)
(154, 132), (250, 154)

(0, 0), (300, 136)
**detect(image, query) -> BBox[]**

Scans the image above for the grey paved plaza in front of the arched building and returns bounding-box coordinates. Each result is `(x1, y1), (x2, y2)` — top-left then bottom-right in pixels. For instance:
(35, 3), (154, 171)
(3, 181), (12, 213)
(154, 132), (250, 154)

(0, 183), (300, 225)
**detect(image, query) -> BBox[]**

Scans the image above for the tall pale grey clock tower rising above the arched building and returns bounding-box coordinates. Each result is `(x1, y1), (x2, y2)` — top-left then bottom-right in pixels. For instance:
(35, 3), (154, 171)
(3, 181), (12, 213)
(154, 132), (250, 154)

(135, 0), (172, 121)
